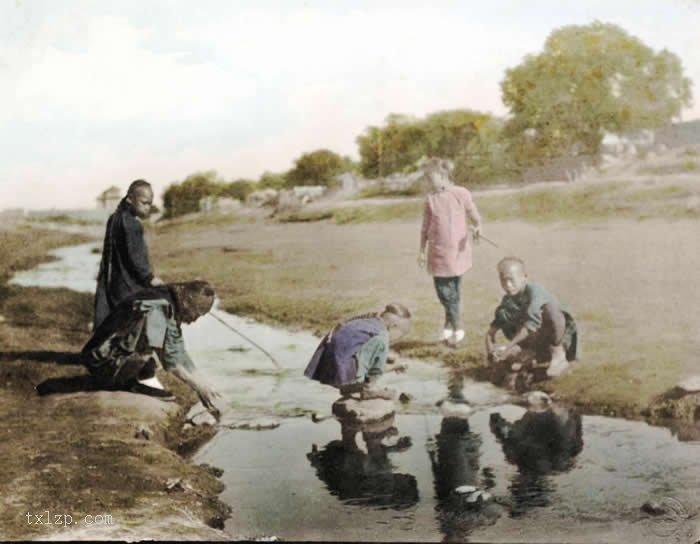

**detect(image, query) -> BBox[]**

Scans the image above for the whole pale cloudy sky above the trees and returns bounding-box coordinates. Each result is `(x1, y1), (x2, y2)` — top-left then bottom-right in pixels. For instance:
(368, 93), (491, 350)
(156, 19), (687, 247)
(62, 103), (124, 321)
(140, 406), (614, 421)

(0, 0), (700, 209)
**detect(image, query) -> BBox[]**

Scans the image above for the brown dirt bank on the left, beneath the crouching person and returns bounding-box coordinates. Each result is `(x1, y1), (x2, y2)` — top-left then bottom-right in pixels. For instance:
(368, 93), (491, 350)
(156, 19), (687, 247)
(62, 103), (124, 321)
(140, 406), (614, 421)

(0, 228), (227, 540)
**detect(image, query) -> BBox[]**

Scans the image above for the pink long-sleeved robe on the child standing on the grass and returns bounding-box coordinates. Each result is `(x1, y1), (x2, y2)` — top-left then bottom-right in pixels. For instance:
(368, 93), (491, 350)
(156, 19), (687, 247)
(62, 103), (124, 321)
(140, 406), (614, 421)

(420, 185), (481, 277)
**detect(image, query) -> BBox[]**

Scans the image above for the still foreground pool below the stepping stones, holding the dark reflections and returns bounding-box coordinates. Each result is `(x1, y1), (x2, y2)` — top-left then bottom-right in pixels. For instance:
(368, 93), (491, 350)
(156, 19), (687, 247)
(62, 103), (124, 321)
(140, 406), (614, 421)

(198, 405), (700, 542)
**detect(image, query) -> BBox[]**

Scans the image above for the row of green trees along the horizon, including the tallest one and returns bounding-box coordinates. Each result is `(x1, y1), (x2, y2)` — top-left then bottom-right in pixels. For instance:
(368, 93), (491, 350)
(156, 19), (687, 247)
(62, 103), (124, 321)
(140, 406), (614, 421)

(164, 22), (692, 217)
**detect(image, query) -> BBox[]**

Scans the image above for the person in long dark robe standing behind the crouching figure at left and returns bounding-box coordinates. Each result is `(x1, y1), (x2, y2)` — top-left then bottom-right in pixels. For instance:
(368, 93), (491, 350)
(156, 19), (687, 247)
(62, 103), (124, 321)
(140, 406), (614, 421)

(93, 179), (163, 330)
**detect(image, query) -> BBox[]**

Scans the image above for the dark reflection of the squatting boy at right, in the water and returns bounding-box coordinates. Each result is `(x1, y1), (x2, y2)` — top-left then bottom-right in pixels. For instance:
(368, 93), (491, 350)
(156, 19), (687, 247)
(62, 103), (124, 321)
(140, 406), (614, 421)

(490, 406), (583, 517)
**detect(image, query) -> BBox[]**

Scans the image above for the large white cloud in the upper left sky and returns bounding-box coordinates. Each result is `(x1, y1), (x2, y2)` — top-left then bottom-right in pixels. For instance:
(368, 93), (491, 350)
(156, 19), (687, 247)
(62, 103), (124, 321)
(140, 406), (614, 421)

(4, 17), (256, 122)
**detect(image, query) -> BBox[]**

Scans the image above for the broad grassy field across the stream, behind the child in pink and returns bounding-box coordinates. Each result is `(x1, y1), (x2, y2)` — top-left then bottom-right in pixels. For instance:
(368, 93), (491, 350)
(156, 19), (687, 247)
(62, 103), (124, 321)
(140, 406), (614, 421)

(153, 178), (700, 414)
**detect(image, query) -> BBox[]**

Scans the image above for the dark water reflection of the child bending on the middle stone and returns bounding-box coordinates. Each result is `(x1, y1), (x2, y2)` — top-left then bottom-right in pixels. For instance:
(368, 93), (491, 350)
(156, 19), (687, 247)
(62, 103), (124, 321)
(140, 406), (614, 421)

(306, 417), (418, 510)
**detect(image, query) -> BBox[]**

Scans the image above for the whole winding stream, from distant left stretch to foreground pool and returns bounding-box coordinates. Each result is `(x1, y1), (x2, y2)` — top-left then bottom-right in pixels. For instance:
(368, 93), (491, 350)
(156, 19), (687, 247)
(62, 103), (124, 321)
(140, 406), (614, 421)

(13, 244), (700, 543)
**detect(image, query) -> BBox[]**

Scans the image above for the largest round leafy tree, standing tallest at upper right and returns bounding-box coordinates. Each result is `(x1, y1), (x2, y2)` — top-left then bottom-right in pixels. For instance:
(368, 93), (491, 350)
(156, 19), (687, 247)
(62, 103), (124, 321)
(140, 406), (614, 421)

(501, 22), (691, 159)
